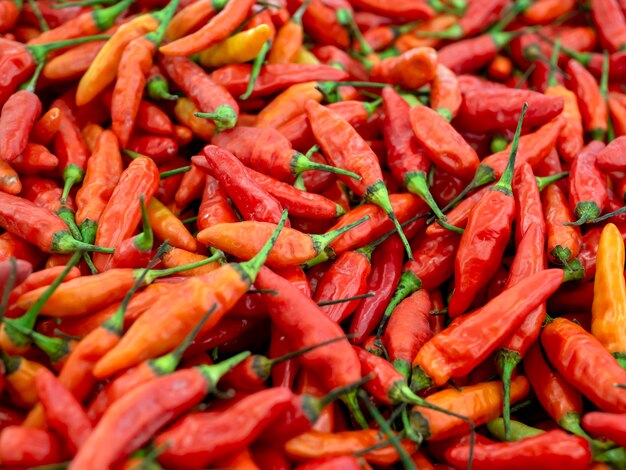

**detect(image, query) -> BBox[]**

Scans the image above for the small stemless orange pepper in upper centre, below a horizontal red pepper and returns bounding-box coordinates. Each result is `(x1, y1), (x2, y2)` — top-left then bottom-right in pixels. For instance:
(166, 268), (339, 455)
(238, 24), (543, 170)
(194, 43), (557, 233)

(255, 82), (324, 128)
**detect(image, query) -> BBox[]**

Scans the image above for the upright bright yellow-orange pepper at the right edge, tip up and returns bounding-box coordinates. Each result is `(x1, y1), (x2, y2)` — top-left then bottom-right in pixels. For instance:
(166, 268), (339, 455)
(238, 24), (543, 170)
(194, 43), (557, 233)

(591, 224), (626, 365)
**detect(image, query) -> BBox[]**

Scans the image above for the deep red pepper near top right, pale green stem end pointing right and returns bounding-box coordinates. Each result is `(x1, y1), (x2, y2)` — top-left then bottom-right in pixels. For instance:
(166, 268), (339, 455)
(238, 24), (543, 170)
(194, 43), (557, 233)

(437, 31), (519, 74)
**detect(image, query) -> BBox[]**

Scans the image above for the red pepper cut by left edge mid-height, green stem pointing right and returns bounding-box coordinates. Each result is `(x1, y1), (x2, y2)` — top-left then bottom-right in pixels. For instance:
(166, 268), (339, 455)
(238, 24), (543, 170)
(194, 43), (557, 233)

(0, 193), (113, 253)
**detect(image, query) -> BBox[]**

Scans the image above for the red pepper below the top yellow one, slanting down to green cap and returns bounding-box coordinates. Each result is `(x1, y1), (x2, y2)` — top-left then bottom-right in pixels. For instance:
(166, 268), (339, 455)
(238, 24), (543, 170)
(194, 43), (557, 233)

(160, 56), (239, 131)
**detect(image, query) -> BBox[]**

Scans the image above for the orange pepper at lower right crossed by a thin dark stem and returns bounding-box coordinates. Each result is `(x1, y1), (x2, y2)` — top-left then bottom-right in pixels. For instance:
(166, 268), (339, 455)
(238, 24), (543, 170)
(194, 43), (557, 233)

(411, 376), (530, 442)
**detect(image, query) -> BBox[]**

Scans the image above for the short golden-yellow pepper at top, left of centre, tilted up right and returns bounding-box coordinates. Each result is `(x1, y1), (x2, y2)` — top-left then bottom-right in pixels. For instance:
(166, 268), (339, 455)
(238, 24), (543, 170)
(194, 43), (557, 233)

(200, 24), (272, 67)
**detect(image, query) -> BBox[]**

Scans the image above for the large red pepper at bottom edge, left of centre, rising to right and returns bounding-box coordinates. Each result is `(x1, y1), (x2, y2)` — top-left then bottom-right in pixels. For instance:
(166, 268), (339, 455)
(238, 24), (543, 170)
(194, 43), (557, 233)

(156, 387), (293, 468)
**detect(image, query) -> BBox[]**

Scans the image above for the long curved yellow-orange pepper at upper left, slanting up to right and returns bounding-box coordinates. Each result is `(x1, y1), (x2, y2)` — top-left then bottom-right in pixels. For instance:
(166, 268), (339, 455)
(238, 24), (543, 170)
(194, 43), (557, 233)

(76, 14), (159, 106)
